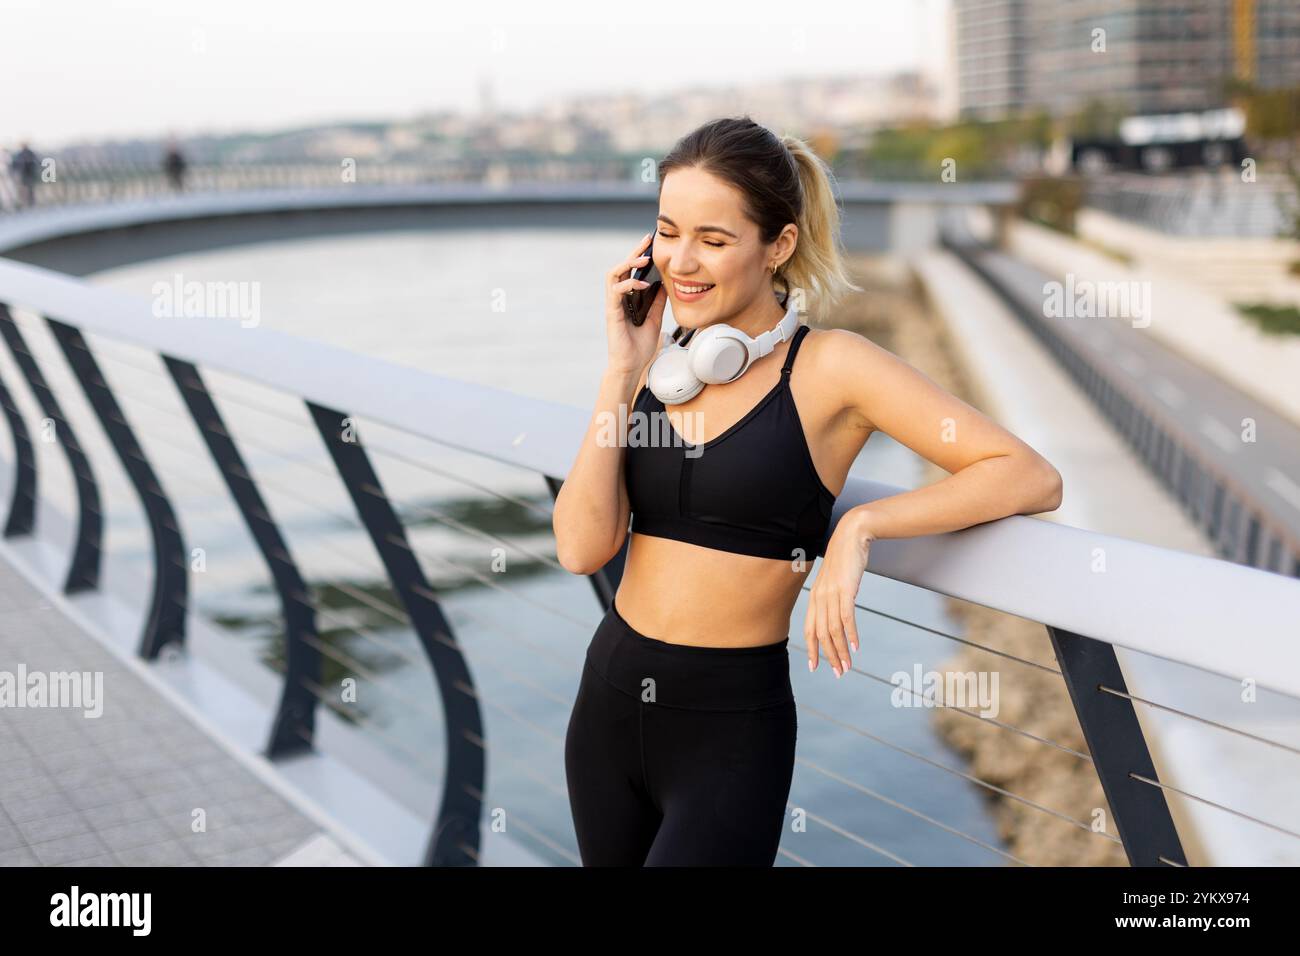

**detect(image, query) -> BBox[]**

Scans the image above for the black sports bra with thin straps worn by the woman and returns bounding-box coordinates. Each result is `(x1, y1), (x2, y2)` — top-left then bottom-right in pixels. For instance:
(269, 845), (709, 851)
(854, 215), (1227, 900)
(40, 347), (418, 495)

(625, 325), (836, 562)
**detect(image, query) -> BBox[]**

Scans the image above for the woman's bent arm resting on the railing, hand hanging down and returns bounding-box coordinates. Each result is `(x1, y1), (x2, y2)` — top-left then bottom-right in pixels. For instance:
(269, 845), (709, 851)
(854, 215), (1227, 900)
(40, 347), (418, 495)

(803, 329), (1061, 676)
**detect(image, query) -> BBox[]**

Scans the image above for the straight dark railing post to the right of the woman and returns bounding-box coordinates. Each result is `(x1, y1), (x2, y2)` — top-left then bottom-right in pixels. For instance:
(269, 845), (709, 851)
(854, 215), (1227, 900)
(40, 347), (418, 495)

(1047, 624), (1187, 866)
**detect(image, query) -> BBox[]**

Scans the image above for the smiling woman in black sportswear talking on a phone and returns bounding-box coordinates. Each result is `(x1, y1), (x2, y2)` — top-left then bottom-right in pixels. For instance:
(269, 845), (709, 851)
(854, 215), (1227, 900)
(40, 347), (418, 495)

(554, 117), (1061, 866)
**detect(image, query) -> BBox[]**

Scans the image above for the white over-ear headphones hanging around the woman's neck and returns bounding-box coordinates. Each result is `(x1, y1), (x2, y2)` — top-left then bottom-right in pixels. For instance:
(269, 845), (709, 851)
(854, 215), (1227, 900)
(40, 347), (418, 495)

(646, 297), (800, 405)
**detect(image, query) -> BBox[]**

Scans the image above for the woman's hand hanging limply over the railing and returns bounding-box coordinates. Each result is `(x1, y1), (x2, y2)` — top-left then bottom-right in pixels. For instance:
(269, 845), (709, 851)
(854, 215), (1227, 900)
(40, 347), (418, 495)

(803, 507), (875, 678)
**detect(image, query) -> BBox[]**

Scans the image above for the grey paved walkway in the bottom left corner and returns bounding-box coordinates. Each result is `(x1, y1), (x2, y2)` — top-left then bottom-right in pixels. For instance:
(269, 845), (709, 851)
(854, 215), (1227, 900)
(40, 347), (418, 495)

(0, 559), (359, 866)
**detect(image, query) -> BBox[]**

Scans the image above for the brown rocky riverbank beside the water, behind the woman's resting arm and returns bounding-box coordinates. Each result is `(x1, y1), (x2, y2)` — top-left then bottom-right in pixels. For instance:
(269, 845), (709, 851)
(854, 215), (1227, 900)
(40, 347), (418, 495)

(837, 256), (1128, 866)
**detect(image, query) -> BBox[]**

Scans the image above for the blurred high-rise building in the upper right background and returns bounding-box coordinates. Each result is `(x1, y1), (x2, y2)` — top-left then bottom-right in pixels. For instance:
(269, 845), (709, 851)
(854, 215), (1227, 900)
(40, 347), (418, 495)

(953, 0), (1300, 120)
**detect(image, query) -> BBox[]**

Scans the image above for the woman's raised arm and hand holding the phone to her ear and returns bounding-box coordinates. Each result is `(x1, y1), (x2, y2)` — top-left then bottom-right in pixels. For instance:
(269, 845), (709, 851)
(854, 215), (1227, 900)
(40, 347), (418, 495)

(551, 234), (667, 575)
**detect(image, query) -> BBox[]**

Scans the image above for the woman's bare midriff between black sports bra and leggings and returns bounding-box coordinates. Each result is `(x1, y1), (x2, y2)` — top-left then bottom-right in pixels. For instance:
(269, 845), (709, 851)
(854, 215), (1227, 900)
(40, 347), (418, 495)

(614, 533), (813, 648)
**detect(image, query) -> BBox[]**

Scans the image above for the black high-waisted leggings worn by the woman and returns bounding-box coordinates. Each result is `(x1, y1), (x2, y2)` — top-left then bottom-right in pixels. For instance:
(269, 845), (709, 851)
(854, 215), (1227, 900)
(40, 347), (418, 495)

(564, 601), (798, 866)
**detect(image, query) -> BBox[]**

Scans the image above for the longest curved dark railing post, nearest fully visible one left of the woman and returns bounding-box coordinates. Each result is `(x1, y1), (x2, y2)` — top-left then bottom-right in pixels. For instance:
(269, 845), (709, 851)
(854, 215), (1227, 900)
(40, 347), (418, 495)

(306, 402), (486, 866)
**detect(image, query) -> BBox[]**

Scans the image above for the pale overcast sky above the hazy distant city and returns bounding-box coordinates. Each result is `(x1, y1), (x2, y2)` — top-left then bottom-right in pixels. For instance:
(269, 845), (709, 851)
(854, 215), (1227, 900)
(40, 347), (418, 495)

(0, 0), (949, 147)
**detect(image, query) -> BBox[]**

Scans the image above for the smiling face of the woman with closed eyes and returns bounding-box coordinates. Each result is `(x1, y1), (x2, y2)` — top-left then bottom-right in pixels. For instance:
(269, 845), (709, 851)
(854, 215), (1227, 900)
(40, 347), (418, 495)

(654, 168), (797, 329)
